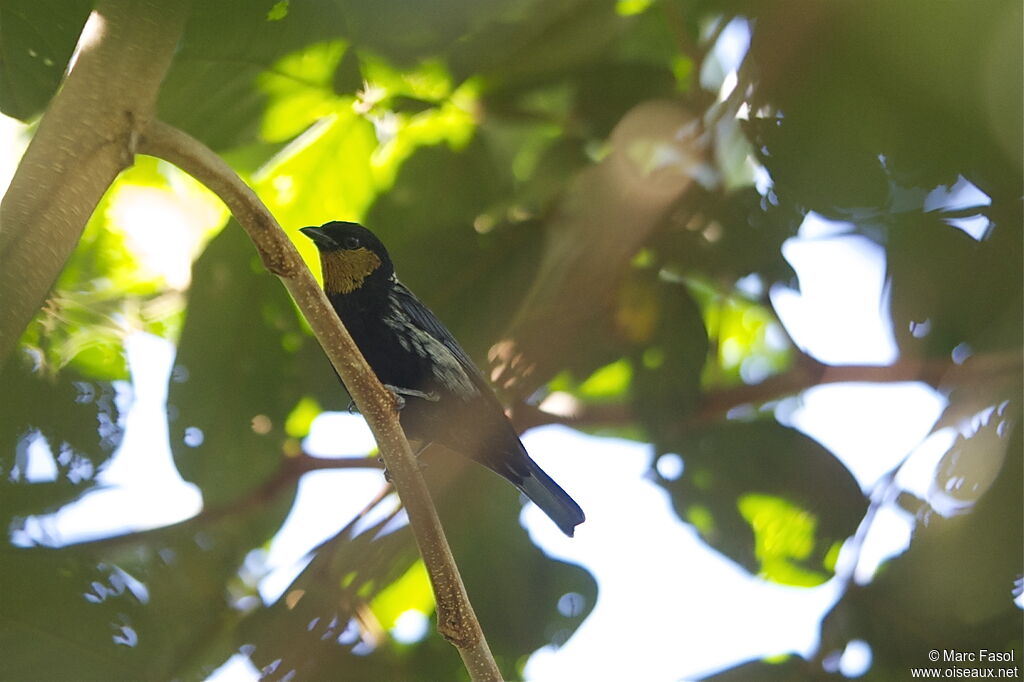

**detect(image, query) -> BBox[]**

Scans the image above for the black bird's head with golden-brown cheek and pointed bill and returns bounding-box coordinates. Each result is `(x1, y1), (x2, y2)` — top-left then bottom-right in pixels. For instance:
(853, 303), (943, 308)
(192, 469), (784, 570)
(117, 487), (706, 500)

(299, 220), (394, 294)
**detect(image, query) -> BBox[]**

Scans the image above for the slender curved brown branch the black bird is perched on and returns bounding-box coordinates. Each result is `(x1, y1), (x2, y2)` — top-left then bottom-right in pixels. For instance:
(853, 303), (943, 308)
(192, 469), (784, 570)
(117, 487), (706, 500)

(138, 121), (501, 680)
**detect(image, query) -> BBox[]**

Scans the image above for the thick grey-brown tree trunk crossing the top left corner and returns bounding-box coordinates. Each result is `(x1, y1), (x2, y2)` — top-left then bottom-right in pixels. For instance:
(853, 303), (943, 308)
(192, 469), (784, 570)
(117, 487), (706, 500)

(0, 0), (189, 367)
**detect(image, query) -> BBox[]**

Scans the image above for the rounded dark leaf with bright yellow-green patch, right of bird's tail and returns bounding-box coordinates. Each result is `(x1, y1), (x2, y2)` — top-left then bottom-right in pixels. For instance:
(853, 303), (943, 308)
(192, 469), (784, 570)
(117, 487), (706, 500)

(658, 421), (867, 585)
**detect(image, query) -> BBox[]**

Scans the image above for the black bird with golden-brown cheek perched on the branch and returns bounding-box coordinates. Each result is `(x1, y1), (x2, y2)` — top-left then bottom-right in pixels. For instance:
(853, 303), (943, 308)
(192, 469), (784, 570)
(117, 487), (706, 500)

(300, 221), (584, 537)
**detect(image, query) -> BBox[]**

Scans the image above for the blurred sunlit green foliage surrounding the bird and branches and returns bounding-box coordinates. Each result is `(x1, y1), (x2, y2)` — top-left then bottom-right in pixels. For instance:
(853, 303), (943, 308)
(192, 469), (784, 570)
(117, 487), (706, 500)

(0, 0), (1024, 680)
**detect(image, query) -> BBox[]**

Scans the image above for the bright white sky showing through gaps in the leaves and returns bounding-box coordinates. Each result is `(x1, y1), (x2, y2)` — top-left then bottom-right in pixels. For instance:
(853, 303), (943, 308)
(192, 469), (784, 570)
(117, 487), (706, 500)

(0, 17), (978, 682)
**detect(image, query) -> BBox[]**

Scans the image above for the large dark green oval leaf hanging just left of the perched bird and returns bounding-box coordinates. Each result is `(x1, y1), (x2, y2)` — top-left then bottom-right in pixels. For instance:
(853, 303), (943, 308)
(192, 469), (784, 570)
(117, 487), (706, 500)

(168, 222), (313, 505)
